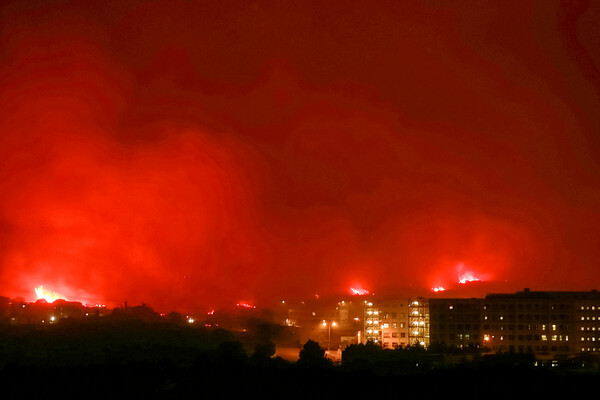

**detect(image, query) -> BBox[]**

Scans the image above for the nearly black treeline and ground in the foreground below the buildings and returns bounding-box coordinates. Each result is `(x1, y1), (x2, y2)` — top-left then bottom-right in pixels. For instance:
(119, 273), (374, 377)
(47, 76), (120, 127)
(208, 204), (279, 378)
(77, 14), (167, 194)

(0, 318), (600, 398)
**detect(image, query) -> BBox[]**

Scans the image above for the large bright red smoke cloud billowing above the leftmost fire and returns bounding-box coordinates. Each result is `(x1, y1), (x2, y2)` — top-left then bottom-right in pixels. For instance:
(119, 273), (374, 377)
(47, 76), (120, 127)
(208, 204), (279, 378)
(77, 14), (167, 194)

(0, 21), (267, 307)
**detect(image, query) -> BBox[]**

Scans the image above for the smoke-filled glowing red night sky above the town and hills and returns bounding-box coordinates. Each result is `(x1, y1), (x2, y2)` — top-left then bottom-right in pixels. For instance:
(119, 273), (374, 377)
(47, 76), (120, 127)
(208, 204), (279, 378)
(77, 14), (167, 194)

(0, 0), (600, 309)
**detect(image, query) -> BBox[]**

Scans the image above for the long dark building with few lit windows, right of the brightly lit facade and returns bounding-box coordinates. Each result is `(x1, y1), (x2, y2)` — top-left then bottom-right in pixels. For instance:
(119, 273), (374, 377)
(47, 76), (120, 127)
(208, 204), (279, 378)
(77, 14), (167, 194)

(430, 289), (600, 359)
